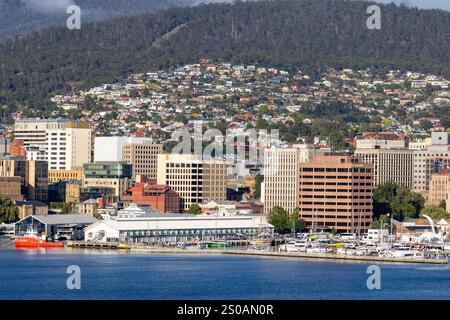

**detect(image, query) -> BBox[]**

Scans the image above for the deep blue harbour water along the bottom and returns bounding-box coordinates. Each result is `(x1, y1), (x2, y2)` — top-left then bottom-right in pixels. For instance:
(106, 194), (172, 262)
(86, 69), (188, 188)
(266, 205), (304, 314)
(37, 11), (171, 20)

(0, 245), (450, 299)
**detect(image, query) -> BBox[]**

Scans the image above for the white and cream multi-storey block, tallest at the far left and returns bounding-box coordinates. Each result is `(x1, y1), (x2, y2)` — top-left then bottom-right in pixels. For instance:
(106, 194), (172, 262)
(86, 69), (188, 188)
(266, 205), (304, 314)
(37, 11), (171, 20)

(14, 119), (92, 170)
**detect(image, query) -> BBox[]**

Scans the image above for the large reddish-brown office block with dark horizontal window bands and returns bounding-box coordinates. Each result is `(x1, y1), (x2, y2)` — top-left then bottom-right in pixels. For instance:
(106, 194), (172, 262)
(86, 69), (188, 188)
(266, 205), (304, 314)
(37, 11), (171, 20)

(298, 156), (373, 234)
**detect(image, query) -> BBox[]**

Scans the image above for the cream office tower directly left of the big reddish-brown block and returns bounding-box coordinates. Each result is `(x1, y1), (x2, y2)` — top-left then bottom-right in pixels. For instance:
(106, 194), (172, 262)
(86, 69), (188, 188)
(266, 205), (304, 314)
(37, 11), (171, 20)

(261, 145), (321, 214)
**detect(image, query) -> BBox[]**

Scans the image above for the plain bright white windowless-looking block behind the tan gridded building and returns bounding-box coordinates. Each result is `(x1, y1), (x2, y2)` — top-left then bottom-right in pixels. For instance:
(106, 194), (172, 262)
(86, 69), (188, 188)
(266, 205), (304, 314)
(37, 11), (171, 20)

(94, 137), (153, 162)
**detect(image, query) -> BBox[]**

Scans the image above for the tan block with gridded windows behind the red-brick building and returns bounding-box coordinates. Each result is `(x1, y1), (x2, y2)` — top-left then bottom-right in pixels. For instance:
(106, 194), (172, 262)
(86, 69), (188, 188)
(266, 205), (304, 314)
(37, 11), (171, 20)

(122, 143), (163, 179)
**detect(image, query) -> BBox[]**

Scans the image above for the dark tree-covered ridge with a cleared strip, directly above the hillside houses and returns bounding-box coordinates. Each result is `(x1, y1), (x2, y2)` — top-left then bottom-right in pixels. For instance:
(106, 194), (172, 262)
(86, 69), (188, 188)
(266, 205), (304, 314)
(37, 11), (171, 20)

(0, 0), (450, 103)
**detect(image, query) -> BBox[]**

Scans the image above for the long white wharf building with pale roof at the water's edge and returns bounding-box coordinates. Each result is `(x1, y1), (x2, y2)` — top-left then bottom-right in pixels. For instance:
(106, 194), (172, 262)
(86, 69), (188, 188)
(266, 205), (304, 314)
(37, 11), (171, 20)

(84, 205), (274, 244)
